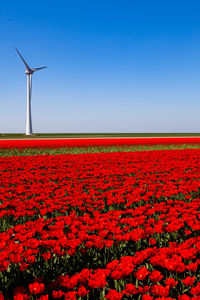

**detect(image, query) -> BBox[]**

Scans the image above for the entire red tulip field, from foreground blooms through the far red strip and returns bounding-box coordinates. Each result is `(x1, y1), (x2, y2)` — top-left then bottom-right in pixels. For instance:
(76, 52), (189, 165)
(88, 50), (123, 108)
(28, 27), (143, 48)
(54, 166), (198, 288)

(0, 138), (200, 300)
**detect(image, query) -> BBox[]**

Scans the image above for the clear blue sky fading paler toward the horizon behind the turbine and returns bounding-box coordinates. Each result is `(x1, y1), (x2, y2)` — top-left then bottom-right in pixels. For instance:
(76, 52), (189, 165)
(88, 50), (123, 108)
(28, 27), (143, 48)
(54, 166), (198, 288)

(0, 0), (200, 132)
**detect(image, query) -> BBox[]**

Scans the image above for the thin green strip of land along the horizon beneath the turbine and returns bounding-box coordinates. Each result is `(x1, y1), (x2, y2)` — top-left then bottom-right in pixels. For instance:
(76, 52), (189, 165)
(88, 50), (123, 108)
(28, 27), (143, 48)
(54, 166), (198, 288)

(0, 132), (200, 139)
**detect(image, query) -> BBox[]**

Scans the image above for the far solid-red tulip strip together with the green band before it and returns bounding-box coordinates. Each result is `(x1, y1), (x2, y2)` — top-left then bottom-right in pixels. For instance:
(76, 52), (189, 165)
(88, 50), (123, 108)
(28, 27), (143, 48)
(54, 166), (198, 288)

(0, 136), (200, 156)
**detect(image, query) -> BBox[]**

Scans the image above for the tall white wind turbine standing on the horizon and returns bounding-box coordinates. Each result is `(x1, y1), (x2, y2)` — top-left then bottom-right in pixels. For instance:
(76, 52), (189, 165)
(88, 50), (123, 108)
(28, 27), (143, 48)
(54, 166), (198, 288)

(15, 47), (47, 135)
